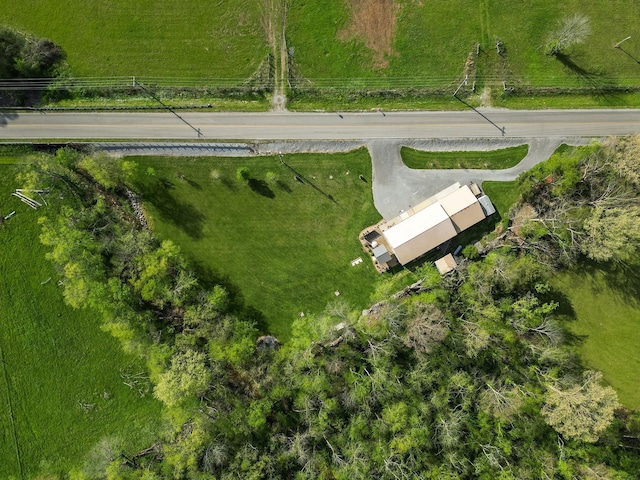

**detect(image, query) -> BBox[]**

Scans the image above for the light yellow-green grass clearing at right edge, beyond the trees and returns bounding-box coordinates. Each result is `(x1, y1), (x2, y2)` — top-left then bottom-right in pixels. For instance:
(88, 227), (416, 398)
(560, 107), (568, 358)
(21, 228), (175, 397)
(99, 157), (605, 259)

(553, 265), (640, 410)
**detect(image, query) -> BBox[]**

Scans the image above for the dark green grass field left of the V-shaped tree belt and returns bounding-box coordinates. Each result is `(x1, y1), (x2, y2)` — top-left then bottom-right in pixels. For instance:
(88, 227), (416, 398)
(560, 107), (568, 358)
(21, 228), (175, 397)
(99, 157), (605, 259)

(0, 163), (161, 479)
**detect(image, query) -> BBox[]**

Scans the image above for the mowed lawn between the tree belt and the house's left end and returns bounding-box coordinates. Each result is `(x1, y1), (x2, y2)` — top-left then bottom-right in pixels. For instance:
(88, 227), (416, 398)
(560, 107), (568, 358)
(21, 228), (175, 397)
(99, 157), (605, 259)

(127, 149), (380, 340)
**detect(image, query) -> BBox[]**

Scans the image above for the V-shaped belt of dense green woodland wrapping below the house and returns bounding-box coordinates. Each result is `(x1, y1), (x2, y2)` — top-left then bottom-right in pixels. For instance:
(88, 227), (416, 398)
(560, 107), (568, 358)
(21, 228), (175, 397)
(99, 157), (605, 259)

(18, 140), (640, 479)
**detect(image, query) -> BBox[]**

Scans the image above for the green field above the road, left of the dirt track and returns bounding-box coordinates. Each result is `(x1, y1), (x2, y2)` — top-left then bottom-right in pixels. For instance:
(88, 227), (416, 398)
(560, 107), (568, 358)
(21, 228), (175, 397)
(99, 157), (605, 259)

(0, 0), (268, 78)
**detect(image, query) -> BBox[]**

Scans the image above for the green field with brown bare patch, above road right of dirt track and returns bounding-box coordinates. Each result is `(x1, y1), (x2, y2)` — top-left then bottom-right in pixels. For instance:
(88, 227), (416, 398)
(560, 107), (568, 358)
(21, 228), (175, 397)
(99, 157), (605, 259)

(287, 0), (640, 88)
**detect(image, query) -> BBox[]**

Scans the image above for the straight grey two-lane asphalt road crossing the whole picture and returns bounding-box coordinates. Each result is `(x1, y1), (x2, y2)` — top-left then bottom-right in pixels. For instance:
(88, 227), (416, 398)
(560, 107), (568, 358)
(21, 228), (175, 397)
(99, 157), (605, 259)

(0, 109), (640, 140)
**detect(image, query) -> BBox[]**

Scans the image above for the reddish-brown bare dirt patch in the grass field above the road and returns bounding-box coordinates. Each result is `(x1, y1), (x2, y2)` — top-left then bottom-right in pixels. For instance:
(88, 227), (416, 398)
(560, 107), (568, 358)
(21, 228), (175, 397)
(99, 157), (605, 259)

(338, 0), (397, 68)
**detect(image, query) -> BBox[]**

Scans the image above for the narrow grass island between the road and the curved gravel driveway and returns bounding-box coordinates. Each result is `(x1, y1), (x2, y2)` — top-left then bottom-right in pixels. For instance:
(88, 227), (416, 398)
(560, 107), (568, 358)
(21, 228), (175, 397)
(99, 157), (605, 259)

(400, 145), (529, 170)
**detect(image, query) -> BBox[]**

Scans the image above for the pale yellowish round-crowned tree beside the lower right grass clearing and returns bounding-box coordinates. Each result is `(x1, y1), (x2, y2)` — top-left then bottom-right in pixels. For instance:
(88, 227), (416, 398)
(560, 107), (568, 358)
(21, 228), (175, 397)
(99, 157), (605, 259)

(542, 371), (619, 442)
